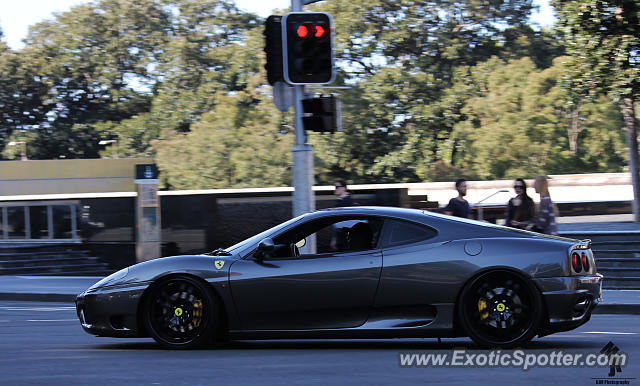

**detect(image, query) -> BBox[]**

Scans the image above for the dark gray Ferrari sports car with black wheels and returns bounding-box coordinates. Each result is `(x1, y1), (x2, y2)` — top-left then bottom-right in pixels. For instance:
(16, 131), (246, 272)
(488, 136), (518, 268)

(76, 206), (602, 348)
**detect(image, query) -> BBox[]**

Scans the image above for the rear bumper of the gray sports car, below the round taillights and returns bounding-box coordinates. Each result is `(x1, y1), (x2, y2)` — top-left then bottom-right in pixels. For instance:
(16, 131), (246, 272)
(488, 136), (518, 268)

(534, 274), (602, 336)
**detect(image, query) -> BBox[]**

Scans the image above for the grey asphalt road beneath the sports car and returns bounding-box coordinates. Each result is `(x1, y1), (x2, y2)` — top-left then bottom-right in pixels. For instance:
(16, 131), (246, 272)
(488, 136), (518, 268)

(0, 302), (640, 386)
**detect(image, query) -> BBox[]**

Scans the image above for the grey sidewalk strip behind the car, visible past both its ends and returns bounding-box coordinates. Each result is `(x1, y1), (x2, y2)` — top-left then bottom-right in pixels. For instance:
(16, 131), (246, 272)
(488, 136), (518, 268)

(0, 276), (640, 315)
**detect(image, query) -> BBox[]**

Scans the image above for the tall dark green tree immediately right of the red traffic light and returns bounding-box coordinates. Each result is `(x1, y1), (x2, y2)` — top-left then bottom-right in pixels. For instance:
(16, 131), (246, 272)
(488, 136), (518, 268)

(313, 0), (552, 182)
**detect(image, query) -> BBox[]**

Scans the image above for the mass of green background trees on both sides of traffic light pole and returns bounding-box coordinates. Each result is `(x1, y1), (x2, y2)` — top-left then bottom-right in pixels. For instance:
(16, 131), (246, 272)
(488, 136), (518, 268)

(0, 0), (638, 185)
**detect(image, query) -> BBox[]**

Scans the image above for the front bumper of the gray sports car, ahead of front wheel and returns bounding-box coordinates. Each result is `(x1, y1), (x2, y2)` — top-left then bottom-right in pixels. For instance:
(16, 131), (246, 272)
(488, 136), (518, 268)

(76, 285), (146, 337)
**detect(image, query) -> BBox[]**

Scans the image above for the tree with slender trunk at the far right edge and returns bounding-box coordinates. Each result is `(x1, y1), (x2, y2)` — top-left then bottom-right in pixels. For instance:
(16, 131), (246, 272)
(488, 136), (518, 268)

(552, 0), (640, 222)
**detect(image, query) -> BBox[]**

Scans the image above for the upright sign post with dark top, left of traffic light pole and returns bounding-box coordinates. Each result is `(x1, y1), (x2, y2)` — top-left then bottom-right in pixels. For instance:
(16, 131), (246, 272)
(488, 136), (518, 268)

(135, 164), (162, 262)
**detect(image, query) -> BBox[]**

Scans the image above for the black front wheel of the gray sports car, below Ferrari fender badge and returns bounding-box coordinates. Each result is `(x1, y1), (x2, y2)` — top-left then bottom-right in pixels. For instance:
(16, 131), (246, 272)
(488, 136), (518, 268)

(142, 276), (220, 349)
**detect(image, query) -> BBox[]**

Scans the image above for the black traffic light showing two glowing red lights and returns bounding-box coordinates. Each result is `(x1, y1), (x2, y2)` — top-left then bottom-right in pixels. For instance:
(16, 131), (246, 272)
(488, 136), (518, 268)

(282, 12), (334, 85)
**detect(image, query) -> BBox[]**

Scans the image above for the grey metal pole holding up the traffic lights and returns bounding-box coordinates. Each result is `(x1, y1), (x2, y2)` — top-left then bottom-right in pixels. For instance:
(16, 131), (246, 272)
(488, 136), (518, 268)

(291, 0), (316, 253)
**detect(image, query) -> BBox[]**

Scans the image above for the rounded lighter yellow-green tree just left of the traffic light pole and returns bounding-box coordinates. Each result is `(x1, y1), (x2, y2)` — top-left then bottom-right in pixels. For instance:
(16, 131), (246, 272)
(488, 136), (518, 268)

(152, 91), (293, 189)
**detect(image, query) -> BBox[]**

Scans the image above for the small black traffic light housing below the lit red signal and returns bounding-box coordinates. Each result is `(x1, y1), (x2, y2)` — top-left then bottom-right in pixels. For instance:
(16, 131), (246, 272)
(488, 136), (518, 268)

(302, 95), (342, 133)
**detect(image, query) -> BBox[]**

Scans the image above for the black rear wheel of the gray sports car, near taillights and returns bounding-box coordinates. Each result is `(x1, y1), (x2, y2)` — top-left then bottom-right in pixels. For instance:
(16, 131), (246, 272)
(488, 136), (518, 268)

(457, 270), (543, 348)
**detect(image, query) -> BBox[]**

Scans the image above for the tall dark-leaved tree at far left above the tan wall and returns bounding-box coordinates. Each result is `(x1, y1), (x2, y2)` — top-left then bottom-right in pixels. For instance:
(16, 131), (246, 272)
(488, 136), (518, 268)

(18, 0), (169, 159)
